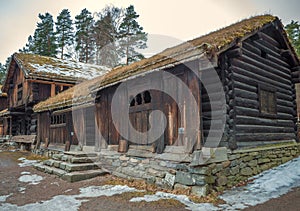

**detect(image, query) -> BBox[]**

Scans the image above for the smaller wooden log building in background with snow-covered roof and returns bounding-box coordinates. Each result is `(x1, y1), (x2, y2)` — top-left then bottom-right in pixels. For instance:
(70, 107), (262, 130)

(0, 53), (108, 136)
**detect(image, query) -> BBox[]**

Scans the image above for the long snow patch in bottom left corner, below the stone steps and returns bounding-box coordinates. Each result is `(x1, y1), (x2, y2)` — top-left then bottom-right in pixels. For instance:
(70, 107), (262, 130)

(0, 185), (138, 211)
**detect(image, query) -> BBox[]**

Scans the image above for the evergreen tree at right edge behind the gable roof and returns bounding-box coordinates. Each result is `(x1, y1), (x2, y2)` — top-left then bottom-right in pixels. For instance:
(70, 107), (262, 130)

(285, 20), (300, 56)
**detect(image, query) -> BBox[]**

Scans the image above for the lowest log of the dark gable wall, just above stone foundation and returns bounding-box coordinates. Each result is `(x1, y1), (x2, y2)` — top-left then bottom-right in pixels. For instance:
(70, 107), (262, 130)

(236, 133), (296, 142)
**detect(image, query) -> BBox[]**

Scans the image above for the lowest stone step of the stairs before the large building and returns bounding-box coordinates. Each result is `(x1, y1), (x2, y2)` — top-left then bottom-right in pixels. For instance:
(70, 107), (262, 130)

(61, 169), (109, 182)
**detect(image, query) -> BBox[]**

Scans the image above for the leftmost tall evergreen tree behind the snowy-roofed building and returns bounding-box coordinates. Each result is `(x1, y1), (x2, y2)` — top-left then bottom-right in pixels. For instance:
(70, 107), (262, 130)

(33, 13), (57, 57)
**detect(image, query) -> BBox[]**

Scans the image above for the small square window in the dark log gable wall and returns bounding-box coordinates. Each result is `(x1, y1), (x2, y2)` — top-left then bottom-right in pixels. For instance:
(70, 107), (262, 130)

(259, 87), (277, 114)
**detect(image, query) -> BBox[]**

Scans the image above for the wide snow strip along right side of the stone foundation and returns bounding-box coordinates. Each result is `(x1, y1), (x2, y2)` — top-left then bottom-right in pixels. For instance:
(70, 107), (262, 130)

(220, 157), (300, 210)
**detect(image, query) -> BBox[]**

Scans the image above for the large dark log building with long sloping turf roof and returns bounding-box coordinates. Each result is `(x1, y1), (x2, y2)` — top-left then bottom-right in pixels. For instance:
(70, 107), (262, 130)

(34, 15), (299, 153)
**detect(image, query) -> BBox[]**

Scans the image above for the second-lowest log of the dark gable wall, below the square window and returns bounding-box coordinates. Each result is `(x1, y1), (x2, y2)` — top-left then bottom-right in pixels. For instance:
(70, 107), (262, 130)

(235, 125), (295, 133)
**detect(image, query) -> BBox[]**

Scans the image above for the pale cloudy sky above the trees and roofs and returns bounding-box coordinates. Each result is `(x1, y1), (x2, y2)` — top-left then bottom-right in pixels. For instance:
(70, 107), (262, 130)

(0, 0), (300, 63)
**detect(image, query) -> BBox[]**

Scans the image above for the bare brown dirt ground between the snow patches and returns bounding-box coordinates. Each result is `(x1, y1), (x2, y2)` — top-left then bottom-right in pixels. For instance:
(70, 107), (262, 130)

(0, 149), (300, 211)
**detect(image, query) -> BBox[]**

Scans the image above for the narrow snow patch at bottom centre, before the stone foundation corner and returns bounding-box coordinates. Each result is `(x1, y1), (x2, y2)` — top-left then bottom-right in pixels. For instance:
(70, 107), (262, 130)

(130, 192), (219, 211)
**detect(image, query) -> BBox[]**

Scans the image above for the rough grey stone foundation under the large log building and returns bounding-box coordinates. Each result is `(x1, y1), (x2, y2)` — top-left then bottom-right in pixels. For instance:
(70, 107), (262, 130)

(34, 142), (300, 196)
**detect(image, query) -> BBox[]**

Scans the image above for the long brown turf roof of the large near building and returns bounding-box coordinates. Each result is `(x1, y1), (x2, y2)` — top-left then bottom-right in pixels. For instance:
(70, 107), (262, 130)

(34, 15), (278, 112)
